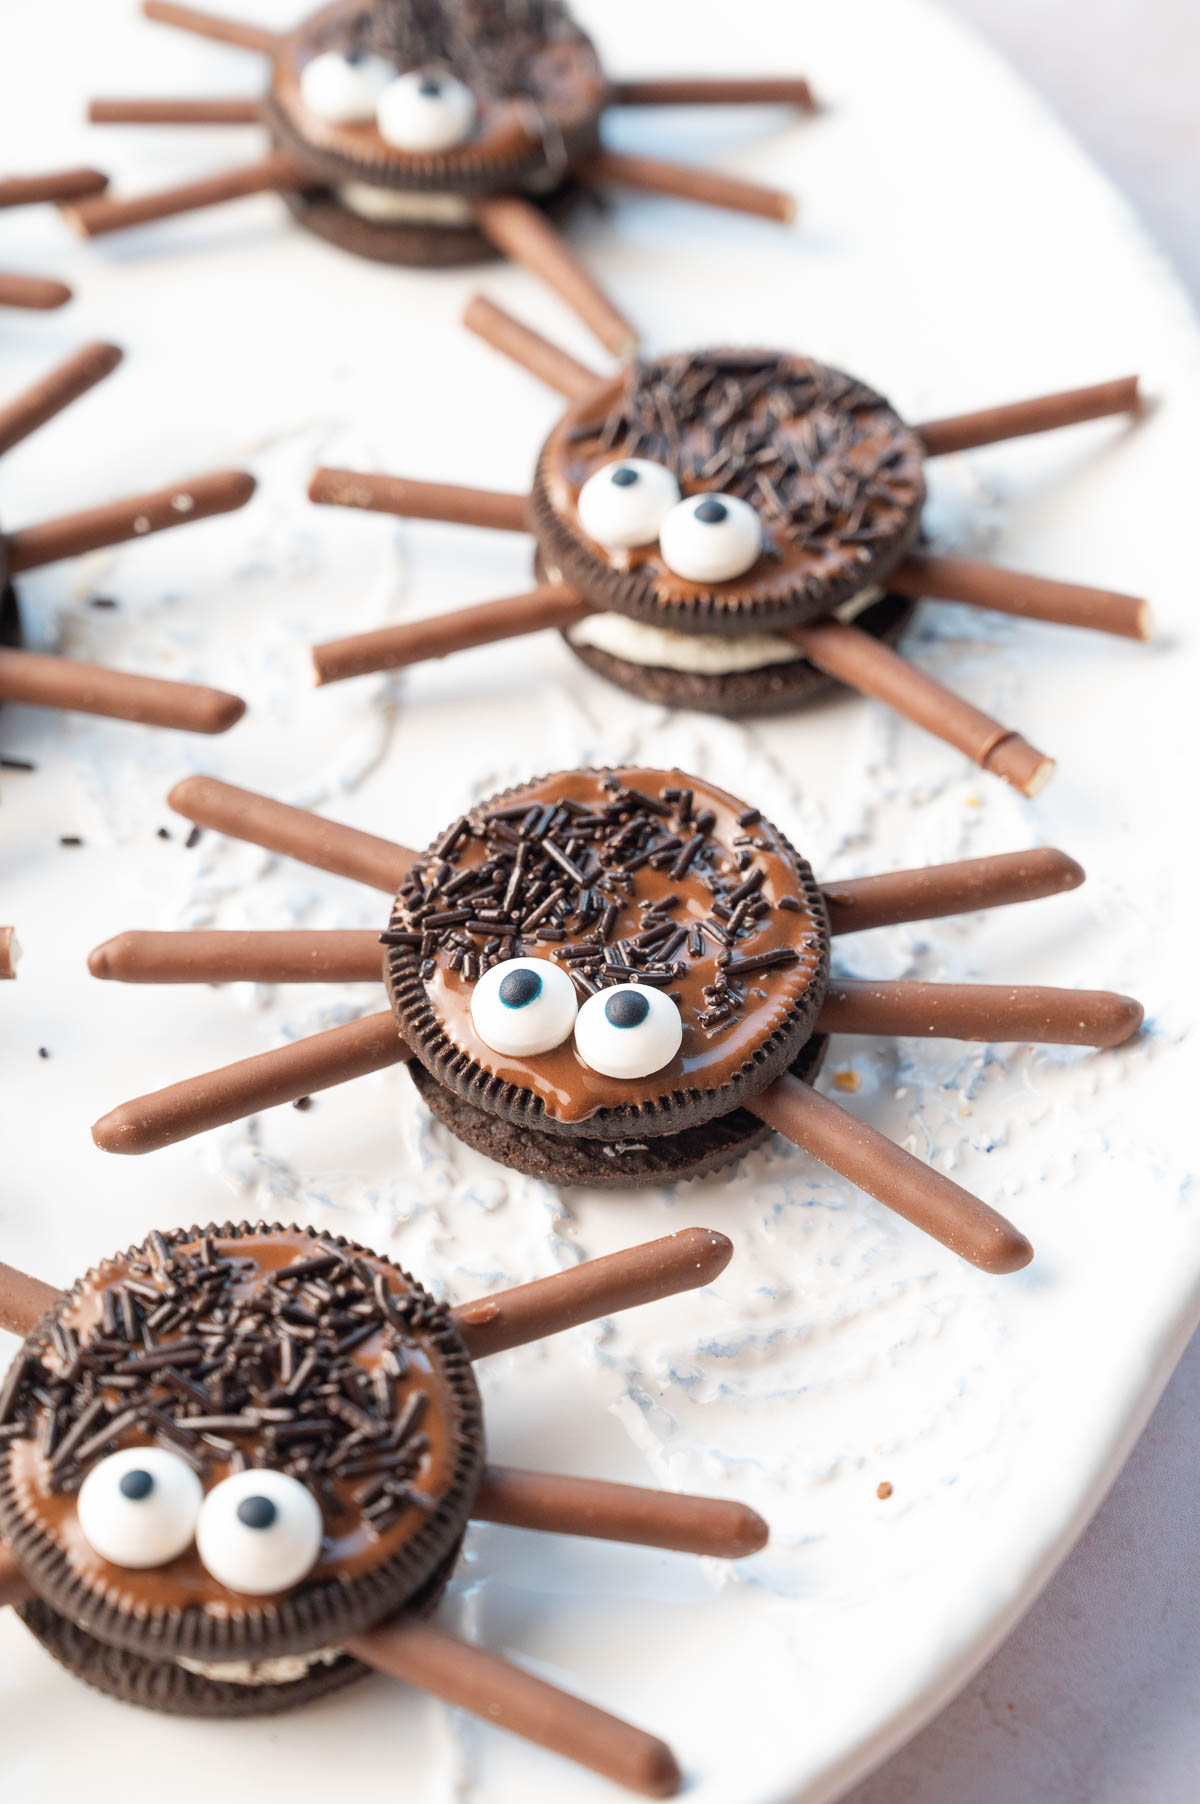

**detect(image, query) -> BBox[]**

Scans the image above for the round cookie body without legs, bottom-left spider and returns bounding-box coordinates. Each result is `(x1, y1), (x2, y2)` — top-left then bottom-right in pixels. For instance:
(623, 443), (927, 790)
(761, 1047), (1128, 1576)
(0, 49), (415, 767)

(0, 1223), (484, 1716)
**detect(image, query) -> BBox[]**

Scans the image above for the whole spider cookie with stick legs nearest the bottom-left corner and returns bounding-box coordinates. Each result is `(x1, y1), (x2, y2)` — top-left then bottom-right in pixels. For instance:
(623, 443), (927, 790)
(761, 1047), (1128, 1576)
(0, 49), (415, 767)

(0, 1223), (767, 1797)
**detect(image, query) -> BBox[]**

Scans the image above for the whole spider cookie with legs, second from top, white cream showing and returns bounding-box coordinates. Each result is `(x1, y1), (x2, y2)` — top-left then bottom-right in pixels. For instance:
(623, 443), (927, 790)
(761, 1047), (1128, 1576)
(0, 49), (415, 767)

(309, 298), (1151, 796)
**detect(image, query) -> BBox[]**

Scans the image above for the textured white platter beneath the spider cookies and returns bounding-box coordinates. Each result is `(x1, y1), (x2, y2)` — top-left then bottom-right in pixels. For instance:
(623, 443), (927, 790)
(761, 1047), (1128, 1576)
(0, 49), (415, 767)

(0, 0), (1200, 1804)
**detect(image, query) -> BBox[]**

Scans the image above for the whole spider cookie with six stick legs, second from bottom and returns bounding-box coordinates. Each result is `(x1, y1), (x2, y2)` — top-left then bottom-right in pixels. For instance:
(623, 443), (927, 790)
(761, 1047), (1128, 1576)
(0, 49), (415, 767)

(88, 769), (1142, 1272)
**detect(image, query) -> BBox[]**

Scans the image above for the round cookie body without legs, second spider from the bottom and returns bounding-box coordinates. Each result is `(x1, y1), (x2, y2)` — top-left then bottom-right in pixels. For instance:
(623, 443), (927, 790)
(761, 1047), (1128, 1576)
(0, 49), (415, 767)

(384, 754), (828, 1183)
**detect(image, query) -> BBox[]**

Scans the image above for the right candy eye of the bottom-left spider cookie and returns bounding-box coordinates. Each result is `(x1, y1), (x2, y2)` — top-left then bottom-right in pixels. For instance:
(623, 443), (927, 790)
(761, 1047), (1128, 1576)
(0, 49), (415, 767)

(197, 1468), (321, 1597)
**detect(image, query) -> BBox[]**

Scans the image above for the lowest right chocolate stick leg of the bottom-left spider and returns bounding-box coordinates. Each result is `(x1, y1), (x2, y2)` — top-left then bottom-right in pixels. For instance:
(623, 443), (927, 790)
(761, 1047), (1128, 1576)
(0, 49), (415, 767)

(341, 1616), (682, 1799)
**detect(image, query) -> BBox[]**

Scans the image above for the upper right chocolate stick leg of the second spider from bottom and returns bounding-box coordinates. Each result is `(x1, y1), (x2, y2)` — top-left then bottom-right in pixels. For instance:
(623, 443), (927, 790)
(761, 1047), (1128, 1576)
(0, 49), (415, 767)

(821, 846), (1085, 933)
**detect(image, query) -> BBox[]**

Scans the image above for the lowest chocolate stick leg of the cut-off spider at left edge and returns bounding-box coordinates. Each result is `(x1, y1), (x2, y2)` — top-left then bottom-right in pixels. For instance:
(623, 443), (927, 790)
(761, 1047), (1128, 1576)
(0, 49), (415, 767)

(0, 646), (245, 732)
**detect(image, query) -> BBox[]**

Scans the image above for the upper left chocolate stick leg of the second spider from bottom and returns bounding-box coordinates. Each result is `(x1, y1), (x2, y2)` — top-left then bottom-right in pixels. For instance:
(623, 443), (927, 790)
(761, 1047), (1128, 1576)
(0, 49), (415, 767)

(166, 778), (415, 895)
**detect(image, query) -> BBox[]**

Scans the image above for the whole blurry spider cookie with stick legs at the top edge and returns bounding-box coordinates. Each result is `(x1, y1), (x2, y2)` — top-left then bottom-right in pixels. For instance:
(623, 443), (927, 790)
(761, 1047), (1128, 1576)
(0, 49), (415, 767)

(82, 0), (812, 354)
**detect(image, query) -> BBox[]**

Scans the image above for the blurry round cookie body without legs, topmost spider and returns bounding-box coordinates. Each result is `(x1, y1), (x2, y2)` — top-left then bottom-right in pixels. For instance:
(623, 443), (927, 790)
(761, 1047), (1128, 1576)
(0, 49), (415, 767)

(263, 0), (608, 263)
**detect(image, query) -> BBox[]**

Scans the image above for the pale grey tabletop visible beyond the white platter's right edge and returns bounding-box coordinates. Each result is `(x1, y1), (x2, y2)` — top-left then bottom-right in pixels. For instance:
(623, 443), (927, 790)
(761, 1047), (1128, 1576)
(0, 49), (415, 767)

(845, 0), (1200, 1804)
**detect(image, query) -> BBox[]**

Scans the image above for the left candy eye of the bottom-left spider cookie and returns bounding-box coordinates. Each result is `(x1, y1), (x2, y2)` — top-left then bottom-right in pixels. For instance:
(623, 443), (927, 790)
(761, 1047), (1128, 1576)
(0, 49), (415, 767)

(76, 1447), (204, 1569)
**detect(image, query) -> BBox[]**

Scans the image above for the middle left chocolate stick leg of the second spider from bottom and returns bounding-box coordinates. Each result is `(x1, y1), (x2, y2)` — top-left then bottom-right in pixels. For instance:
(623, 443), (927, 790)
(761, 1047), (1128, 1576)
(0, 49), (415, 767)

(91, 927), (383, 983)
